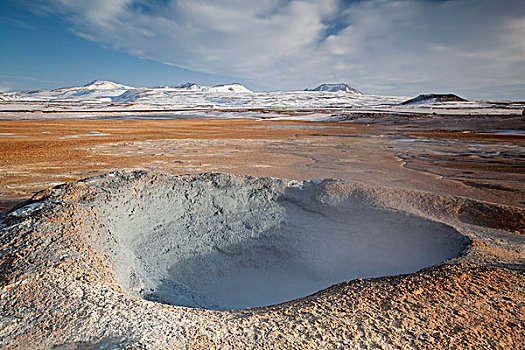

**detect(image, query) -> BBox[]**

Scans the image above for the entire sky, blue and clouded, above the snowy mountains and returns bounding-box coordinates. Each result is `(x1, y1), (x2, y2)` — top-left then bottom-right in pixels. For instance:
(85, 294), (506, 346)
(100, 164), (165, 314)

(0, 0), (525, 100)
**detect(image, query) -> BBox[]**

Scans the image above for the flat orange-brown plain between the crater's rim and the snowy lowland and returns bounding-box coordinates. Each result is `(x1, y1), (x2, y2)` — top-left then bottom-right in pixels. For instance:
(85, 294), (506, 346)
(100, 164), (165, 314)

(0, 119), (525, 213)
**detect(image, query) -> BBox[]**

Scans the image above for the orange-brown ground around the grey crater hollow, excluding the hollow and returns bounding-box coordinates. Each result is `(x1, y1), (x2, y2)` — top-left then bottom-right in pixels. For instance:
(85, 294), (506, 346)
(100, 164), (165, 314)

(0, 115), (525, 349)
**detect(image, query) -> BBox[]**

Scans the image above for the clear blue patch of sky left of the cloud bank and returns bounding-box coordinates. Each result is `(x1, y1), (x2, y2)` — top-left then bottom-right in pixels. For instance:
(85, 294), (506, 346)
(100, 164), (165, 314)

(0, 0), (247, 90)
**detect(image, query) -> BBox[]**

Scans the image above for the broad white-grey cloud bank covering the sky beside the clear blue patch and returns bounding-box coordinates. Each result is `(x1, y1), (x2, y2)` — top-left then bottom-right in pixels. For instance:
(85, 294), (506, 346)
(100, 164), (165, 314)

(29, 0), (525, 96)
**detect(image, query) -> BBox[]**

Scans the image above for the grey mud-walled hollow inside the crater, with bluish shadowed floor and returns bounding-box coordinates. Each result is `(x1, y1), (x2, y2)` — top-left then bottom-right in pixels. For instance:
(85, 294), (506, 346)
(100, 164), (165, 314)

(98, 174), (466, 310)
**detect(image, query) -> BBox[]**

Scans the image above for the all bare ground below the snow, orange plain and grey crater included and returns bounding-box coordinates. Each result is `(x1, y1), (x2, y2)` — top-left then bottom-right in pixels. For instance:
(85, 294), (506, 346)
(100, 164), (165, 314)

(0, 113), (525, 349)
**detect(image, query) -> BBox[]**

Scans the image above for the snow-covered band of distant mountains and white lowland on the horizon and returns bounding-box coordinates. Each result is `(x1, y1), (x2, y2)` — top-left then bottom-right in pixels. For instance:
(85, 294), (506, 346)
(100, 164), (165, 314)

(0, 80), (525, 115)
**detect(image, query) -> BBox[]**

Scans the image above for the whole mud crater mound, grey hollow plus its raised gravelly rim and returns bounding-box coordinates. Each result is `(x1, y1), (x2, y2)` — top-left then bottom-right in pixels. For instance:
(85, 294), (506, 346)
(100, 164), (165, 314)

(2, 172), (523, 348)
